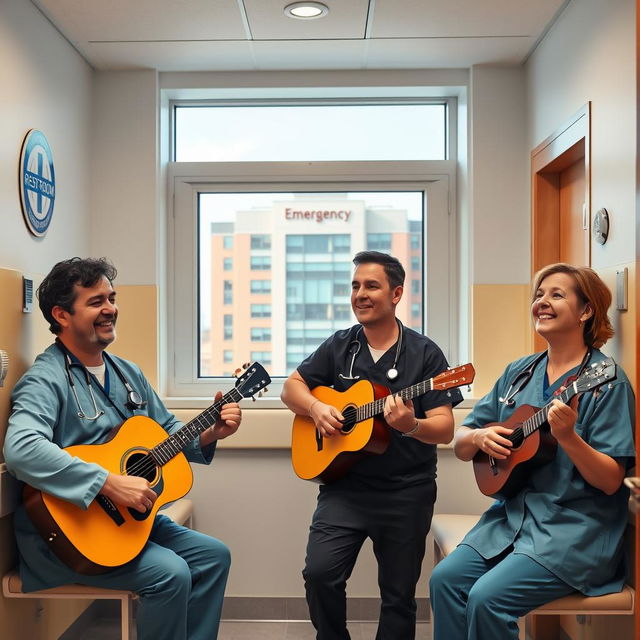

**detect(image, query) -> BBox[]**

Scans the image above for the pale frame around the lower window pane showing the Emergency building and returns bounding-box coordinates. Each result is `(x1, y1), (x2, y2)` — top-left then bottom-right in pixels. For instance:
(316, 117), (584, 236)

(166, 162), (458, 407)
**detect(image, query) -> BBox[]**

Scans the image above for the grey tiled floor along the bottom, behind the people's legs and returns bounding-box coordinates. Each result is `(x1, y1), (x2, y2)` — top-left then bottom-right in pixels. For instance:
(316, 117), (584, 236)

(60, 618), (431, 640)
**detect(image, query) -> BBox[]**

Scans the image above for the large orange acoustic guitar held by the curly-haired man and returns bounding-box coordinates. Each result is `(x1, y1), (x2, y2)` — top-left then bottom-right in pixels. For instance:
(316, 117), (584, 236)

(24, 363), (271, 575)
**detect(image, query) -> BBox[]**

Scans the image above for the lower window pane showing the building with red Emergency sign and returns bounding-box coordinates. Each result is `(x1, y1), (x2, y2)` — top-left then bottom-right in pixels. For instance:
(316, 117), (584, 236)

(198, 191), (424, 377)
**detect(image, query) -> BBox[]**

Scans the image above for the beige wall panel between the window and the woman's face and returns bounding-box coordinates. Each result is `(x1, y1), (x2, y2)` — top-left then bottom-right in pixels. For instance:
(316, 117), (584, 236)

(472, 284), (532, 398)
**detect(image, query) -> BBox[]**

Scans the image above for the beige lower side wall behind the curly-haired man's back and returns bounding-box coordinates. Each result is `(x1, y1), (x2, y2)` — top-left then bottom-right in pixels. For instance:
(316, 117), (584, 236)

(0, 269), (90, 640)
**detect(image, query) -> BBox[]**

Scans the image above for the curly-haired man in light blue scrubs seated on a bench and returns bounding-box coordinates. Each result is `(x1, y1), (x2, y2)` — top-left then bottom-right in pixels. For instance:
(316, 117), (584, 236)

(4, 258), (241, 640)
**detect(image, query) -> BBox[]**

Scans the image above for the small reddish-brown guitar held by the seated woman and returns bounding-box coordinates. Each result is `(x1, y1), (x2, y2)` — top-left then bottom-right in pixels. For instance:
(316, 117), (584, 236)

(473, 358), (616, 500)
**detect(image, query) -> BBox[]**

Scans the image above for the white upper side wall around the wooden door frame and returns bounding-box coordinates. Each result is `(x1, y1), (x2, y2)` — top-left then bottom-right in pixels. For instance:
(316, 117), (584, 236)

(526, 0), (636, 269)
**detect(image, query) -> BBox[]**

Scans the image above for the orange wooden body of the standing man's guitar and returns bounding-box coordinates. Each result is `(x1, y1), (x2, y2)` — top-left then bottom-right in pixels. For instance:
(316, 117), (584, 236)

(291, 380), (391, 484)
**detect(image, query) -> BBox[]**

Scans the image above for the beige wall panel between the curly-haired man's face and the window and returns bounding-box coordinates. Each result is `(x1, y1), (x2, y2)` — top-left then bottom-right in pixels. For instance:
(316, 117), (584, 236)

(109, 281), (158, 390)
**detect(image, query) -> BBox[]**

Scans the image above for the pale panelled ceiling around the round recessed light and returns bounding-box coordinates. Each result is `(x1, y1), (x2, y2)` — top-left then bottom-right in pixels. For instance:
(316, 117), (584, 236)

(31, 0), (577, 71)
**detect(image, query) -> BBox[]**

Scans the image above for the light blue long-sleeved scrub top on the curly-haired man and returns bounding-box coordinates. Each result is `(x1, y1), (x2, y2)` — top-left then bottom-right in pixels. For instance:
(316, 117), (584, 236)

(4, 344), (215, 591)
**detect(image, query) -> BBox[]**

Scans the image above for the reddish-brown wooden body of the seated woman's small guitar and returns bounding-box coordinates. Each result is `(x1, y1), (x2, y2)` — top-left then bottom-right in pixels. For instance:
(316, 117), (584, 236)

(473, 404), (558, 499)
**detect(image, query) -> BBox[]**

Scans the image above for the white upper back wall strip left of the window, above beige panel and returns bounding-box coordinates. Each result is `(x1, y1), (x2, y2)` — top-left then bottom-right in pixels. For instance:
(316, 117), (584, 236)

(91, 71), (160, 284)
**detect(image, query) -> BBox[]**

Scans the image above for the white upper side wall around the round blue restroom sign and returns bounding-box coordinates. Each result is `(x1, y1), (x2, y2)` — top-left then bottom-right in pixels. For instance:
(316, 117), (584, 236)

(0, 0), (93, 273)
